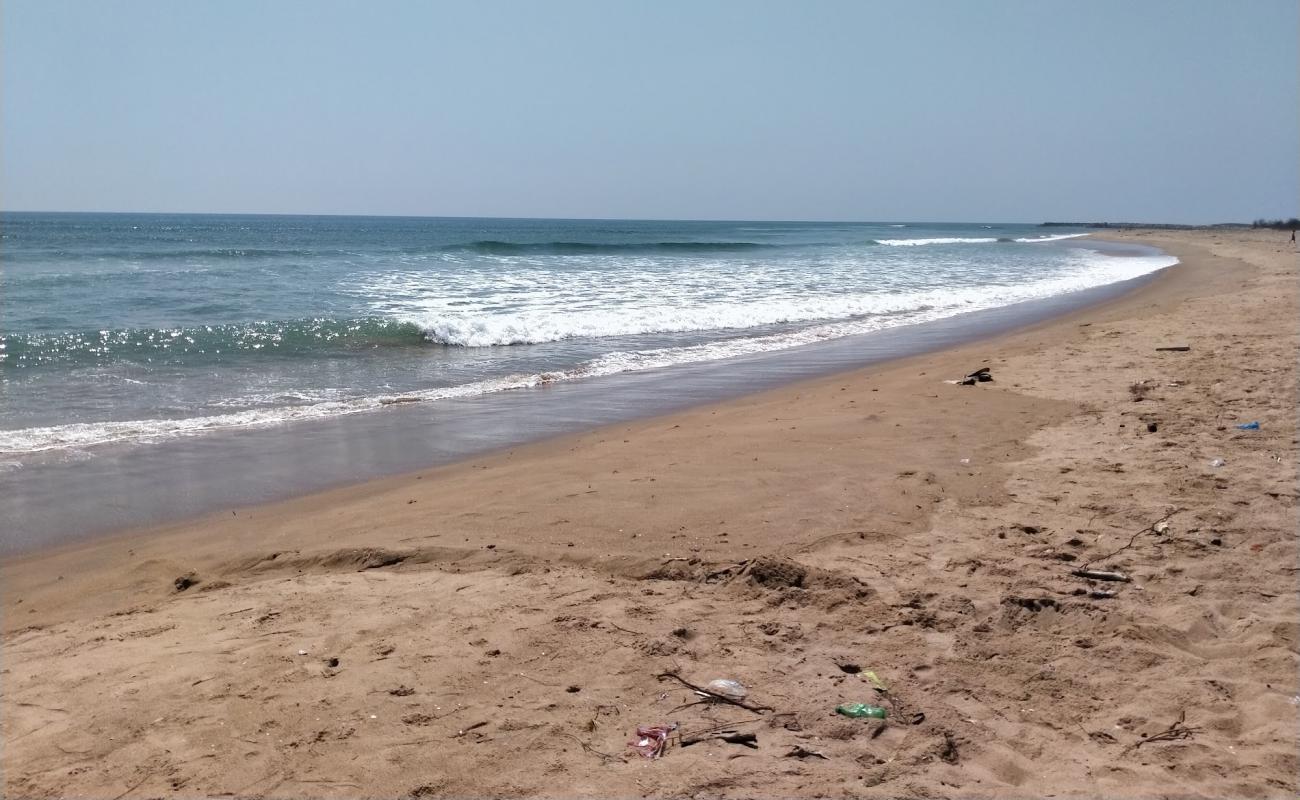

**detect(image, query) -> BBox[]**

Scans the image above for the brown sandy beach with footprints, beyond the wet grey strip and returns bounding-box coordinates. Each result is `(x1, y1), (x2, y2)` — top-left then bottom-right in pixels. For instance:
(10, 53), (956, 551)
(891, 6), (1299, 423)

(0, 230), (1300, 799)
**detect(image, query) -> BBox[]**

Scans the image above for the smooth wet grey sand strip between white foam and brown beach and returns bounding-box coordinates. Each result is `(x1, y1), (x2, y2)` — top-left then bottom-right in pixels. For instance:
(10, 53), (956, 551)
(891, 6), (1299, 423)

(0, 239), (1161, 558)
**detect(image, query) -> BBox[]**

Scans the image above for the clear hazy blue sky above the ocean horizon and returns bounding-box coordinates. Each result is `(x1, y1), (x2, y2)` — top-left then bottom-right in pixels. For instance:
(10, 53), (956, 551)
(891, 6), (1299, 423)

(0, 0), (1300, 222)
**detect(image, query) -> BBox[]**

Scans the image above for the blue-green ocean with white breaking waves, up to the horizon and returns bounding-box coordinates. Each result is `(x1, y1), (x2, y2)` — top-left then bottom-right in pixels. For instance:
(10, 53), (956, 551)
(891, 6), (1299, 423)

(0, 212), (1175, 544)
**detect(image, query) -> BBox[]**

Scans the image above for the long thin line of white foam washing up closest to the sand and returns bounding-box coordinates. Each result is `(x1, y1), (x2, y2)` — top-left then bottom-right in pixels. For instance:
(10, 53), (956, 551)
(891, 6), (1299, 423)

(0, 251), (1178, 455)
